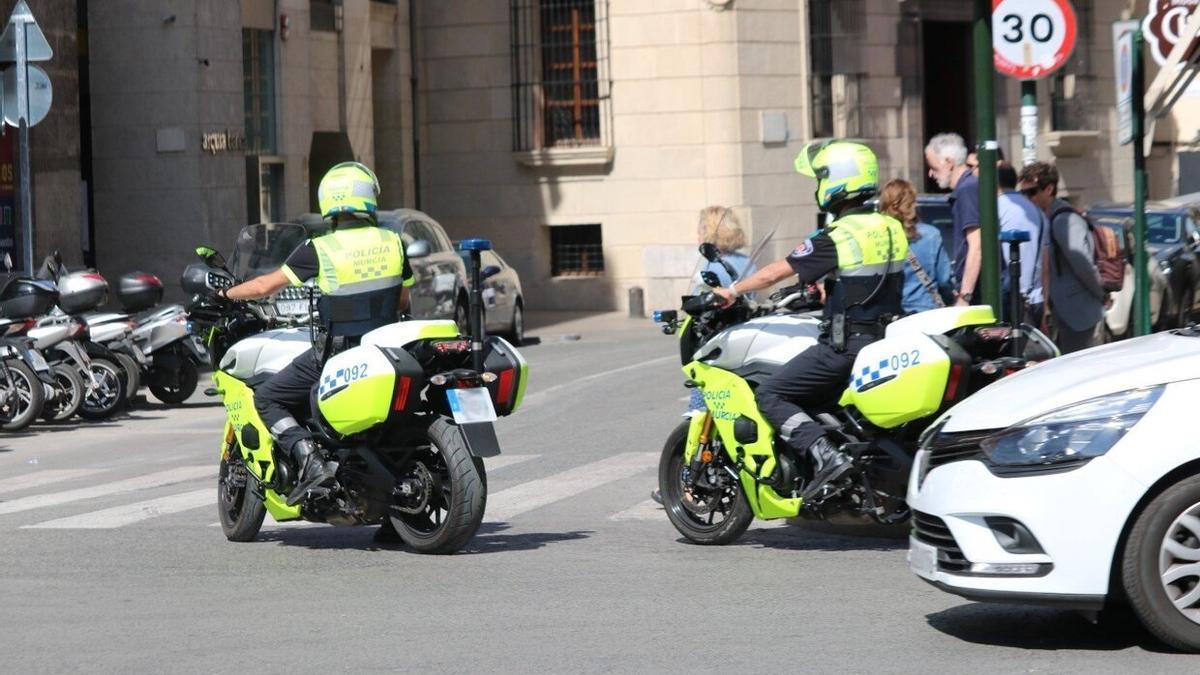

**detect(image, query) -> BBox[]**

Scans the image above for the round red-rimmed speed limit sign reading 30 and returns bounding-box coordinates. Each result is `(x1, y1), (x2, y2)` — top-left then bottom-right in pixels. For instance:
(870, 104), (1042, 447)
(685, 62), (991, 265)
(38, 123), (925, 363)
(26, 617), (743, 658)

(991, 0), (1076, 79)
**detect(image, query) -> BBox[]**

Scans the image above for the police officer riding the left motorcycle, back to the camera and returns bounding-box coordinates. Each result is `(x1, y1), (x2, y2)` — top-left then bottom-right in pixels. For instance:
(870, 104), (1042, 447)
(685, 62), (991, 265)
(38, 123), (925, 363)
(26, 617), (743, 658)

(218, 162), (413, 504)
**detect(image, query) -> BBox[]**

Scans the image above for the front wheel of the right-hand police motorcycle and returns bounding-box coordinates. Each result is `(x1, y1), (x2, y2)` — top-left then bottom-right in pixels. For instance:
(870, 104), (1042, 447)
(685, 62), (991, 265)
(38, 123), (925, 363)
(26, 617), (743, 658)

(659, 420), (754, 545)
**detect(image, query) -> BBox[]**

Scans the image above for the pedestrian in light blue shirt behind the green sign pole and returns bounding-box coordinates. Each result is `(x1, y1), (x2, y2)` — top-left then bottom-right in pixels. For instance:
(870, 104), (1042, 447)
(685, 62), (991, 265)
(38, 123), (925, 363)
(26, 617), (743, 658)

(996, 161), (1046, 325)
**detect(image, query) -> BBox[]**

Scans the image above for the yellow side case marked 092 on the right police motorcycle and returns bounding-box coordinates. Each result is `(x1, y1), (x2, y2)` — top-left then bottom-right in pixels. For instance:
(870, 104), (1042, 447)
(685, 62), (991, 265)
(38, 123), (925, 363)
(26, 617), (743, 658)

(840, 333), (950, 429)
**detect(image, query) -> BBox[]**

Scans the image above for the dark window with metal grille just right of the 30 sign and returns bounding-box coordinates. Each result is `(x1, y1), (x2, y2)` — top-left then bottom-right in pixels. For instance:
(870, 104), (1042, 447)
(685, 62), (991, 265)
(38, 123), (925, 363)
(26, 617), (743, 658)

(1050, 0), (1098, 131)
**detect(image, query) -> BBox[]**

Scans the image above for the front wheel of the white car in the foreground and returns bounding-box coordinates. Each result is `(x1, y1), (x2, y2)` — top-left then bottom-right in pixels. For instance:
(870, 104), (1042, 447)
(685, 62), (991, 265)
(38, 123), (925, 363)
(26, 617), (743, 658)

(1121, 476), (1200, 651)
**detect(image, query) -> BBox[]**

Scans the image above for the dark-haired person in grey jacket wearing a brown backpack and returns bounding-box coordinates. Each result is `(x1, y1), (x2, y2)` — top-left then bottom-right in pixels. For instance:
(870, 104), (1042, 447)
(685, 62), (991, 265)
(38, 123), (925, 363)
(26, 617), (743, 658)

(1020, 162), (1124, 354)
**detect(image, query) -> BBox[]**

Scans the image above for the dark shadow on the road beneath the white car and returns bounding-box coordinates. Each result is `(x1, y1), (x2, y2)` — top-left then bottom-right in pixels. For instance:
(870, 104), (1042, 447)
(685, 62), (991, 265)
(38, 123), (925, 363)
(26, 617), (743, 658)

(925, 603), (1172, 653)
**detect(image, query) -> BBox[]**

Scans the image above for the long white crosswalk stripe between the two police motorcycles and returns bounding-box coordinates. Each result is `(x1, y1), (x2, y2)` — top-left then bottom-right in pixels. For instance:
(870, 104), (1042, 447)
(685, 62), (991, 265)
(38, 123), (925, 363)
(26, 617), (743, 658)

(484, 453), (659, 521)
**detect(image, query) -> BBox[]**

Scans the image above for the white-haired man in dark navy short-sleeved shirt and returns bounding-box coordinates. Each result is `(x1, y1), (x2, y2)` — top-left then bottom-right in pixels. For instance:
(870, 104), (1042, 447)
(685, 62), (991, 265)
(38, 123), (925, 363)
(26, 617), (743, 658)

(925, 133), (983, 305)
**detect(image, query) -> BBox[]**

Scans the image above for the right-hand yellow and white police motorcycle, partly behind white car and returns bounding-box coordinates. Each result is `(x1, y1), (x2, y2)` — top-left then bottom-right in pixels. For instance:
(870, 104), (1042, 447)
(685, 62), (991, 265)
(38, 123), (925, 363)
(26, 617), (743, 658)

(656, 240), (1058, 544)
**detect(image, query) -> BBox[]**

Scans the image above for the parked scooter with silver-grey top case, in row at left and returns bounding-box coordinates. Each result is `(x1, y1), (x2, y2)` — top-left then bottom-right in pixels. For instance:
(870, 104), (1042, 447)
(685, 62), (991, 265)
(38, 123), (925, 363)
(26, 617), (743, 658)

(24, 251), (132, 422)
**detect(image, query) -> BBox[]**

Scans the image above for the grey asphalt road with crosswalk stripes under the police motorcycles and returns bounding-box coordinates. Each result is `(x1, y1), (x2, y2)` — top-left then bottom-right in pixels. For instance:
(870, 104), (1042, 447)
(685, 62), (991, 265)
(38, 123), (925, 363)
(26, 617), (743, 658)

(0, 312), (1200, 674)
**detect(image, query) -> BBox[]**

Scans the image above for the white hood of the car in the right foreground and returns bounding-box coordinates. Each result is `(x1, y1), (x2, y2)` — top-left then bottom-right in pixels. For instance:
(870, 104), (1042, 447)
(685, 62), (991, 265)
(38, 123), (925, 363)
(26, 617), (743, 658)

(942, 333), (1200, 432)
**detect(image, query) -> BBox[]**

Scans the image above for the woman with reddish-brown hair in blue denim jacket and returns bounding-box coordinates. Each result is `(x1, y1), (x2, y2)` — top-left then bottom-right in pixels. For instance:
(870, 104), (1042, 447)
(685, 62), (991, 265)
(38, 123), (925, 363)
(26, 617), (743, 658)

(880, 179), (954, 313)
